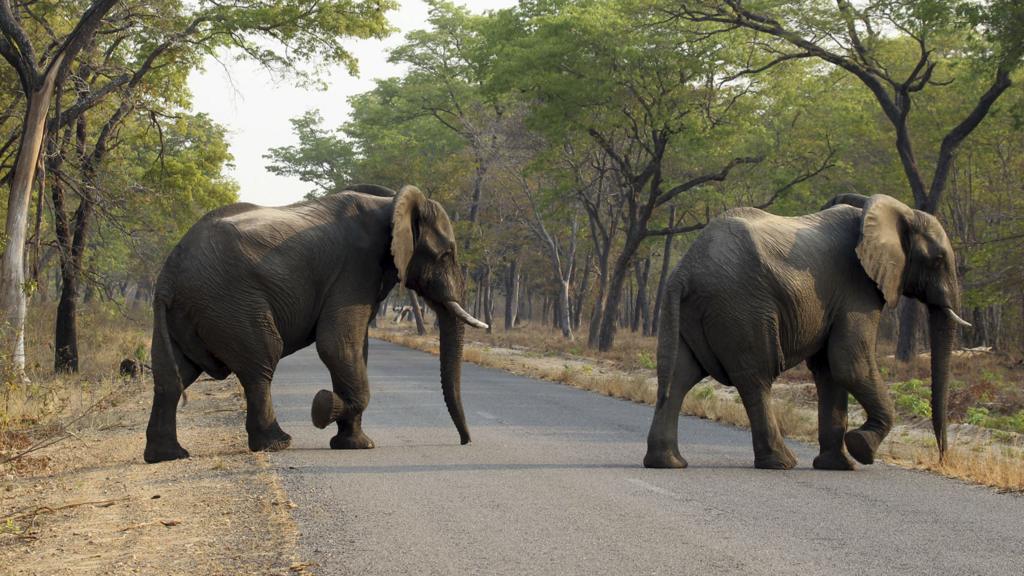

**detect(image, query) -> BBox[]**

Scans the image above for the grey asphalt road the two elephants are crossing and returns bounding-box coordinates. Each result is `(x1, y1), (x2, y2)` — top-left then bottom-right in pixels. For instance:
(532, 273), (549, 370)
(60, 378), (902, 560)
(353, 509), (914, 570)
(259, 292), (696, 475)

(270, 341), (1024, 576)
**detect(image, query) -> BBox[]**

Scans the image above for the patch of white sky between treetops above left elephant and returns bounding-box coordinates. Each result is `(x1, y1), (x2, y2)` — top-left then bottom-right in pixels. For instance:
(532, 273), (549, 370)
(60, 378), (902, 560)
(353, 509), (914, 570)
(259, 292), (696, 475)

(188, 0), (516, 206)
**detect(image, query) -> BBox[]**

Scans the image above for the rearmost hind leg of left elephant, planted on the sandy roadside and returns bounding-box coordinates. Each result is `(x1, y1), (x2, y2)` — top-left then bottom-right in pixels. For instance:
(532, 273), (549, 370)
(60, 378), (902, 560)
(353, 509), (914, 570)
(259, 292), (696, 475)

(142, 336), (202, 464)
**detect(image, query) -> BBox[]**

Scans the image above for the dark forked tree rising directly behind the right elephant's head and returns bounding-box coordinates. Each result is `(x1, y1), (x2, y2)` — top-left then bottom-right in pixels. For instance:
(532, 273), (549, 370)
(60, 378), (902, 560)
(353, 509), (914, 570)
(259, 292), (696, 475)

(665, 0), (1024, 361)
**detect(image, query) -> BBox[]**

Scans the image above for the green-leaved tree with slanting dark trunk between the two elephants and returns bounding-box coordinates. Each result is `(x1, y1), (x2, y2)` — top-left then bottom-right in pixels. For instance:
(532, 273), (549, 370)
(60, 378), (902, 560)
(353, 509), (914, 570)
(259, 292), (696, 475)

(496, 0), (829, 351)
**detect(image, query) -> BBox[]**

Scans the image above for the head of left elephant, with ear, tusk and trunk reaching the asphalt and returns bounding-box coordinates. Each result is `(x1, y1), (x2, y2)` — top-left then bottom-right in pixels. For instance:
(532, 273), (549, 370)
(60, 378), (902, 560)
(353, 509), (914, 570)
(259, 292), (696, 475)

(391, 186), (487, 444)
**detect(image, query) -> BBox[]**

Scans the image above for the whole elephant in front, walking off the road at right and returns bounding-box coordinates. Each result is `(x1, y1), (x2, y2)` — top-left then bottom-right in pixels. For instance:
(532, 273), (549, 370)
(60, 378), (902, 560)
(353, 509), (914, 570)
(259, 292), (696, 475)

(643, 194), (970, 470)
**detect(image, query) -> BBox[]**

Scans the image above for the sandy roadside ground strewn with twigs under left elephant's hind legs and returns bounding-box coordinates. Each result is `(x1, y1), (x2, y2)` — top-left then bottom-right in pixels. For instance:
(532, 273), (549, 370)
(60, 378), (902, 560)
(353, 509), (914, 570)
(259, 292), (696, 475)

(0, 378), (308, 575)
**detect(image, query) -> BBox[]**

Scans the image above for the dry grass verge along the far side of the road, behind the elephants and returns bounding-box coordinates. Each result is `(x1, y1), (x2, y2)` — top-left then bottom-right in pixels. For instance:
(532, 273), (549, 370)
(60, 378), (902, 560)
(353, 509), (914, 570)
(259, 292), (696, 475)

(371, 319), (1024, 491)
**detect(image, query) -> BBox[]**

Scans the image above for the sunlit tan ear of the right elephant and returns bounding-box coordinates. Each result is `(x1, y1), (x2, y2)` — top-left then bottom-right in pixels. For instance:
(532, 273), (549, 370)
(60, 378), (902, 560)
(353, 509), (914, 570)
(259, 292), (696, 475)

(857, 194), (913, 305)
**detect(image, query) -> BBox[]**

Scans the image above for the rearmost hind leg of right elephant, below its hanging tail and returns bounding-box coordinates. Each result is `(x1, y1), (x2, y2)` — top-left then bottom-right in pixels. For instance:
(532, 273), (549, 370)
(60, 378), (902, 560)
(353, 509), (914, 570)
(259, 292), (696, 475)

(643, 334), (708, 468)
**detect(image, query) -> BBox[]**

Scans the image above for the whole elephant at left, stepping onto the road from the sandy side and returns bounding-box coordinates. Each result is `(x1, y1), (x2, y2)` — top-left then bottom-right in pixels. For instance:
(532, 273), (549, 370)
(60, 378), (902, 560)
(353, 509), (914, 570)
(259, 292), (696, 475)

(143, 184), (486, 462)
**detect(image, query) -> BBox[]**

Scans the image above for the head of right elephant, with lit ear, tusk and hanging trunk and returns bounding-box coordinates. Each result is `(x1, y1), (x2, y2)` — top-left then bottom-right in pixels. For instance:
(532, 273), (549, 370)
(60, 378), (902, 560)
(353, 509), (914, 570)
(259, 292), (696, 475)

(844, 194), (970, 453)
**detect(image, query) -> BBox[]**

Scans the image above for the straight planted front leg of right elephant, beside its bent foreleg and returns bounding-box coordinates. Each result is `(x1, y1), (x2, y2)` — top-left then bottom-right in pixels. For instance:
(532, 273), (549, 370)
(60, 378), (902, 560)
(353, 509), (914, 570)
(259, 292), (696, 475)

(807, 351), (853, 470)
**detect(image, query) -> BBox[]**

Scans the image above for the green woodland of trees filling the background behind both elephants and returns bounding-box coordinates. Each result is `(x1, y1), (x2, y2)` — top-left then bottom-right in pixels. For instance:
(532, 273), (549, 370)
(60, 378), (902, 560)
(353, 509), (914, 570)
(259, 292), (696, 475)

(0, 0), (1024, 382)
